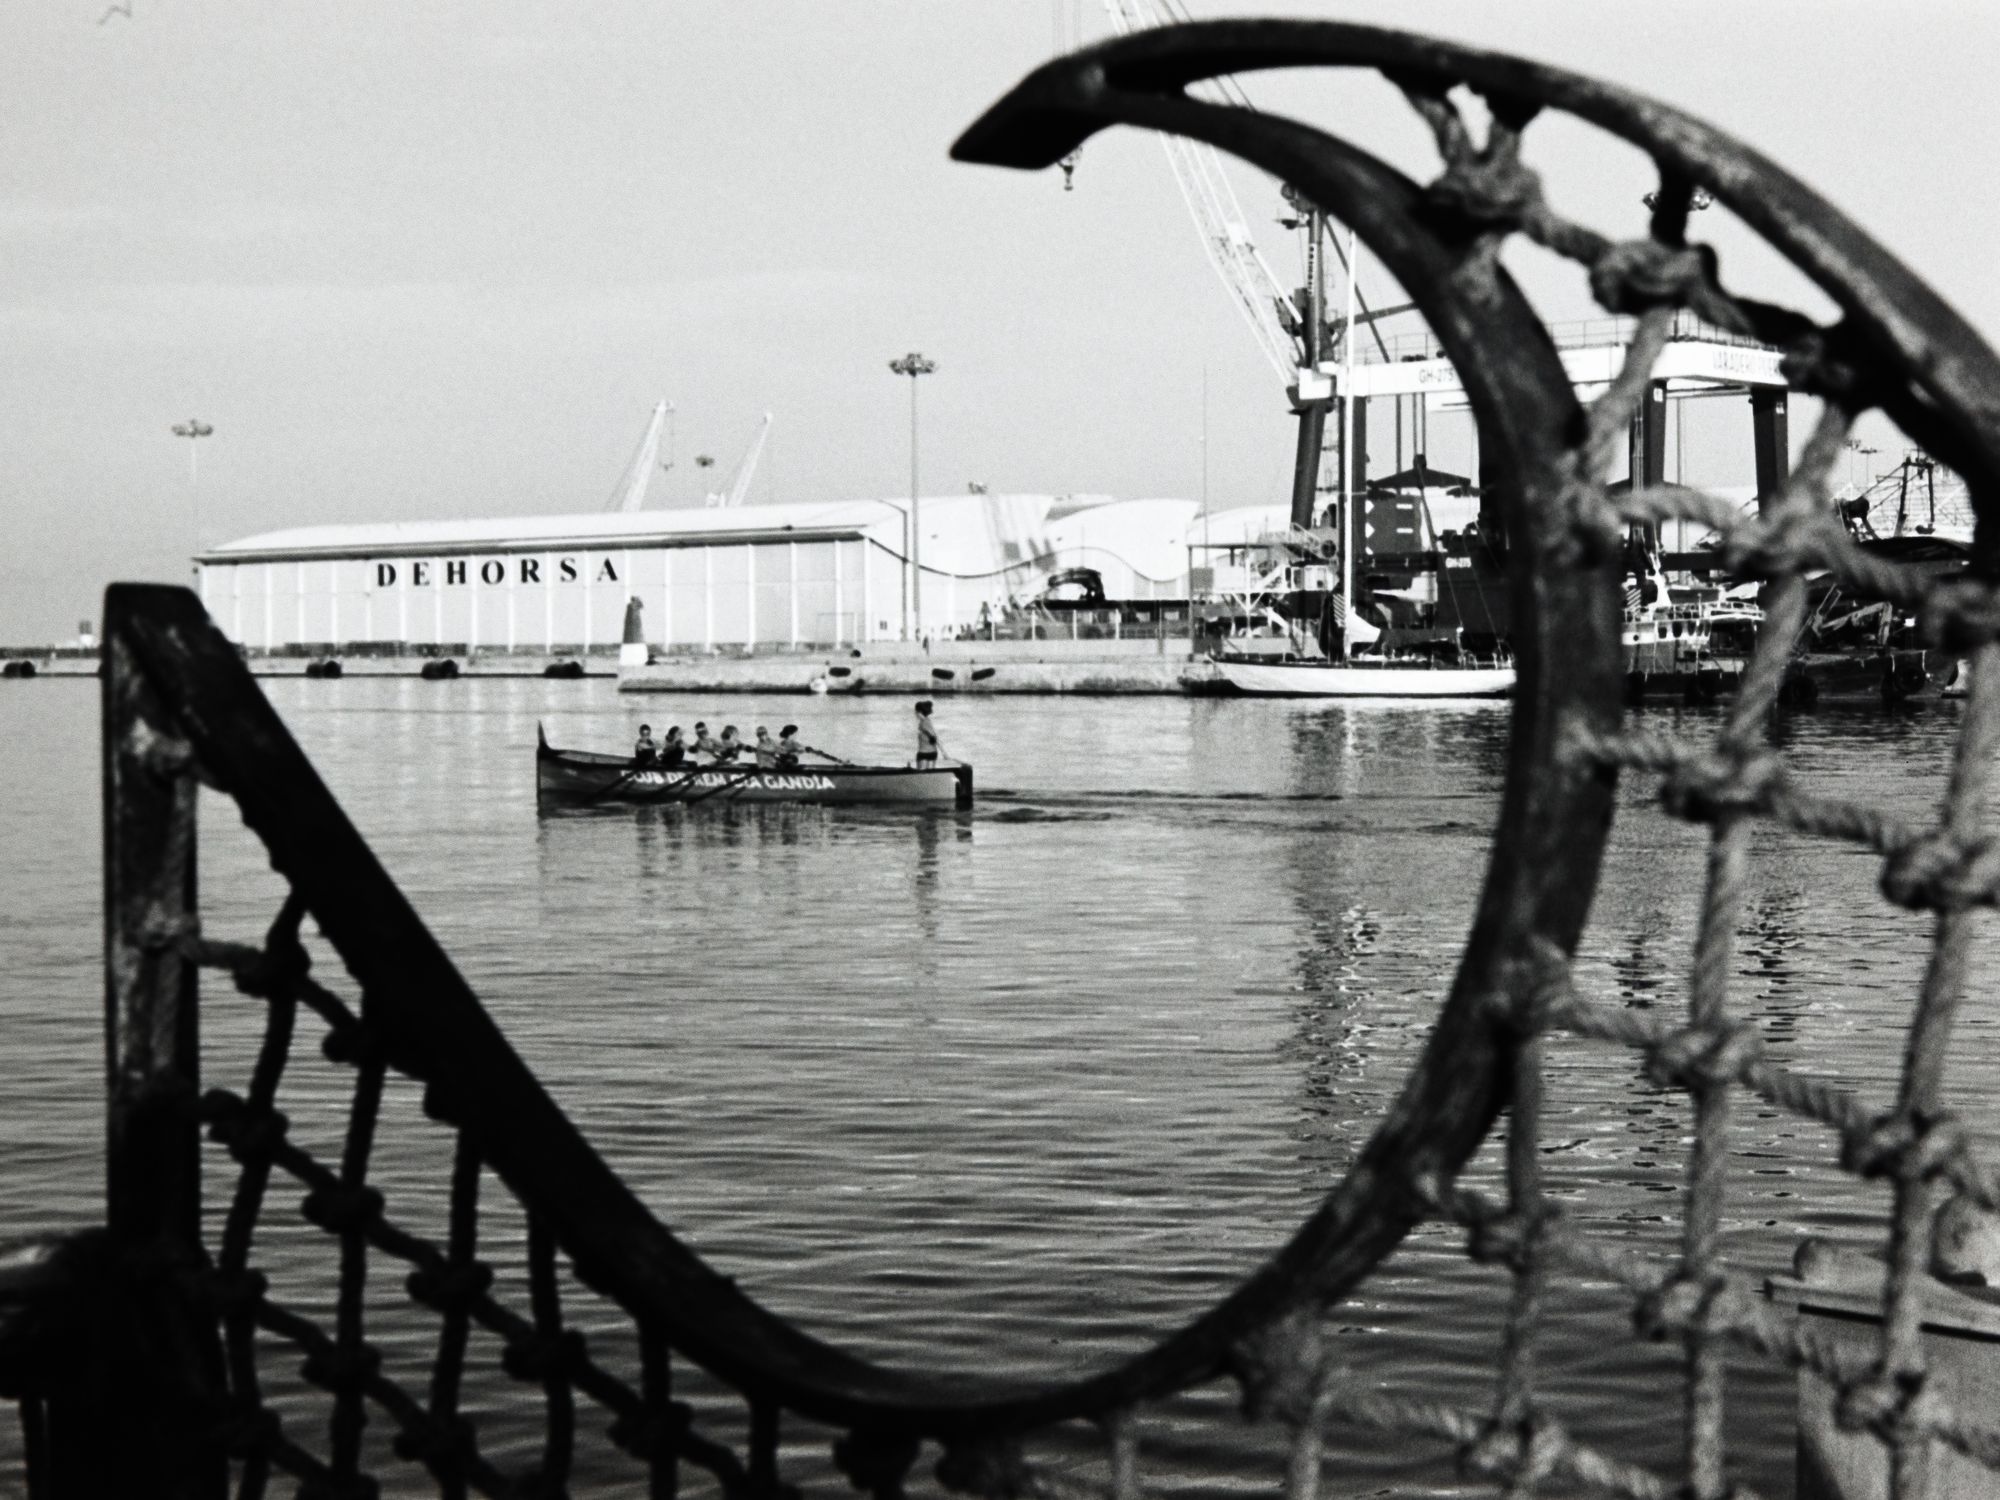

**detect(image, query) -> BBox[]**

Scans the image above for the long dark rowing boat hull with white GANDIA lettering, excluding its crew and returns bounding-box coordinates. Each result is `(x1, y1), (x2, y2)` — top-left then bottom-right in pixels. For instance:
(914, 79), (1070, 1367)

(534, 726), (972, 808)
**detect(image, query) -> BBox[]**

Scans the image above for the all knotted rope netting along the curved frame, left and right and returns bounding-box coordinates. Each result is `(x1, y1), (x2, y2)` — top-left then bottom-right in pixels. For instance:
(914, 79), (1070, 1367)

(66, 20), (2000, 1500)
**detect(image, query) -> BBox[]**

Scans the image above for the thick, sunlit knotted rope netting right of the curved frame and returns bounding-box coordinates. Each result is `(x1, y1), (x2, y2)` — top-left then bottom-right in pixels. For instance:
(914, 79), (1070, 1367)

(1232, 84), (2000, 1500)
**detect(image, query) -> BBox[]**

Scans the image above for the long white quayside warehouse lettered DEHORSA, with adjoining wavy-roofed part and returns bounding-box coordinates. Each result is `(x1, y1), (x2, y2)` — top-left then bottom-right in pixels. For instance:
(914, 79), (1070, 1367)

(196, 494), (1262, 654)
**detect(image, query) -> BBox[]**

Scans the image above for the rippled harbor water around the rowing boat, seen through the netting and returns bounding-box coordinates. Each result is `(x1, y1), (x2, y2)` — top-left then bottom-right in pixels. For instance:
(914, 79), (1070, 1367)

(0, 680), (2000, 1494)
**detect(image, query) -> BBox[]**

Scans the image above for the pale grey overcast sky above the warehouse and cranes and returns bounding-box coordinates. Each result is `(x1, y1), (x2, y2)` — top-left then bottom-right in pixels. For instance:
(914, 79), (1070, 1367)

(0, 0), (2000, 642)
